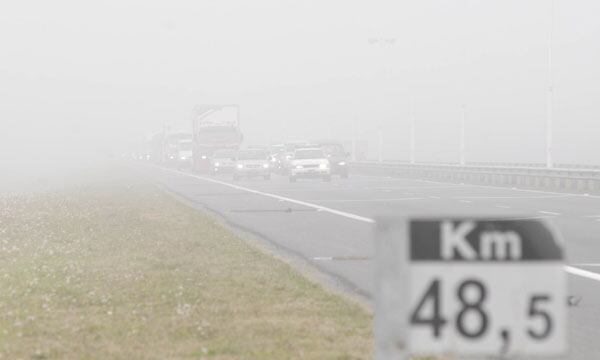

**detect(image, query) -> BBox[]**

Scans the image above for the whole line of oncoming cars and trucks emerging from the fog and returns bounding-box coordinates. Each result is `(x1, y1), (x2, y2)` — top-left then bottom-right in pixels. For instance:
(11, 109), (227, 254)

(143, 105), (350, 182)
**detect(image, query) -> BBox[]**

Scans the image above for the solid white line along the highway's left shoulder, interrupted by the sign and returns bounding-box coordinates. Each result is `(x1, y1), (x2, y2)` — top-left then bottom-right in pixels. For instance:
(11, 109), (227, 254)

(161, 168), (600, 281)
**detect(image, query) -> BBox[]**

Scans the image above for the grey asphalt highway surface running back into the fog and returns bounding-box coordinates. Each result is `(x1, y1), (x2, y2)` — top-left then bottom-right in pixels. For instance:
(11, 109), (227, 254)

(140, 167), (600, 360)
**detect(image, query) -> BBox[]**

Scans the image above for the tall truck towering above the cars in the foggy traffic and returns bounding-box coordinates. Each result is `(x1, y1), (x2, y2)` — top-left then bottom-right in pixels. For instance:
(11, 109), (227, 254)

(192, 104), (244, 172)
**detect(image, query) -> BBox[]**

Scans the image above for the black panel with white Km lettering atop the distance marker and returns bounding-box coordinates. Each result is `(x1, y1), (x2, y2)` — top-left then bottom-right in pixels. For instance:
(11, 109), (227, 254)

(409, 218), (563, 262)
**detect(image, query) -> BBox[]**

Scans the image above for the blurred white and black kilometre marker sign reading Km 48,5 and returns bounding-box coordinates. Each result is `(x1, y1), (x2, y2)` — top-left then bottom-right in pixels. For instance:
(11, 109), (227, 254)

(375, 217), (567, 359)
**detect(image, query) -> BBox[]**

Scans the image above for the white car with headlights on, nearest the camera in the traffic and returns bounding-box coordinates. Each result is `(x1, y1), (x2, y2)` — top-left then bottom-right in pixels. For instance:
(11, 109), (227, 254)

(289, 148), (331, 182)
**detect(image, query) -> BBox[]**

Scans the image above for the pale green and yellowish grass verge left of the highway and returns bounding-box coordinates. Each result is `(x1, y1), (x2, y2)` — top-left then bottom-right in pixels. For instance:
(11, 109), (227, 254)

(0, 170), (372, 359)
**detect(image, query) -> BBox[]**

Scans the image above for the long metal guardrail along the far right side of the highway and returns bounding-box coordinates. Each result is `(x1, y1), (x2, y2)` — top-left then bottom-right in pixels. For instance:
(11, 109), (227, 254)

(352, 161), (600, 193)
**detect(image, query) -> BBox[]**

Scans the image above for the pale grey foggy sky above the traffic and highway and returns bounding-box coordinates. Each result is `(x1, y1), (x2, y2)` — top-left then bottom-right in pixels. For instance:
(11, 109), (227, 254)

(0, 0), (600, 164)
